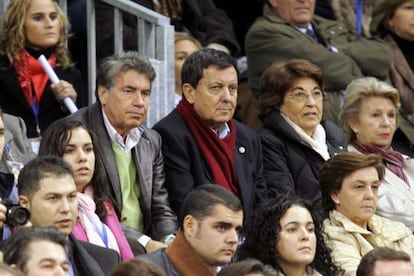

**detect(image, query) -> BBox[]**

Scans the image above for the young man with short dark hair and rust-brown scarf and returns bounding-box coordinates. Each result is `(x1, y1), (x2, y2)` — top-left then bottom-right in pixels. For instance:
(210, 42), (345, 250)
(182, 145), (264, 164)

(140, 184), (243, 276)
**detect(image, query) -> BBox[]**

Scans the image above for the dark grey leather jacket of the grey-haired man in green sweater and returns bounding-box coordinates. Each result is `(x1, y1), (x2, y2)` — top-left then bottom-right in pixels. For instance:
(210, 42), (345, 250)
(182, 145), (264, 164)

(68, 103), (177, 240)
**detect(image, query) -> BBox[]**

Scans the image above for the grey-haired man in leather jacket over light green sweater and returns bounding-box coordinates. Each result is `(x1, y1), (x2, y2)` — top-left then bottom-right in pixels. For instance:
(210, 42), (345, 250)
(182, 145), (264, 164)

(65, 52), (177, 252)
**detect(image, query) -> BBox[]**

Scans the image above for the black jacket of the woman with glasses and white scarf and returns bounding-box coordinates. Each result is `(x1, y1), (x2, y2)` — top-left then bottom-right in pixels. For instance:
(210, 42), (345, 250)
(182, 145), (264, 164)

(259, 111), (347, 206)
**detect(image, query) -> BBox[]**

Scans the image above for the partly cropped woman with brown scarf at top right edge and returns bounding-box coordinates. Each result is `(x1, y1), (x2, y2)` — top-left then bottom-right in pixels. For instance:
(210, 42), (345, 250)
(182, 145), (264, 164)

(371, 0), (414, 157)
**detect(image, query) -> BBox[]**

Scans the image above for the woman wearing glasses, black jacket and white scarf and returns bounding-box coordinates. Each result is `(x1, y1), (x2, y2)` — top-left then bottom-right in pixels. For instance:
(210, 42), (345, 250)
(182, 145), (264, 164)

(259, 59), (347, 203)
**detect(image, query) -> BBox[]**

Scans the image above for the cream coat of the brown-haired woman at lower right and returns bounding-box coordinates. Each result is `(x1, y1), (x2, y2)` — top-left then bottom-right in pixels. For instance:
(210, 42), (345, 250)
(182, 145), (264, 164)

(323, 210), (414, 275)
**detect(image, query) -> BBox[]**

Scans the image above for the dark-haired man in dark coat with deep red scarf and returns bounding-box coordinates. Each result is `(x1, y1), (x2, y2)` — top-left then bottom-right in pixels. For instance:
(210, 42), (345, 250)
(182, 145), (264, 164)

(154, 49), (267, 224)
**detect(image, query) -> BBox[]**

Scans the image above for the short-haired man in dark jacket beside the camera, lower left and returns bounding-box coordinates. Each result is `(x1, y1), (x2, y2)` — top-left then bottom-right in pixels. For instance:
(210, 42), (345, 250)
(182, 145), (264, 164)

(18, 156), (120, 276)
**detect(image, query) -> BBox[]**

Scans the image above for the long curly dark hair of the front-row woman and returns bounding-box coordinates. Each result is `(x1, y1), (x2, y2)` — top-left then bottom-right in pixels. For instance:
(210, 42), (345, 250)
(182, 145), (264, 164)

(238, 195), (344, 276)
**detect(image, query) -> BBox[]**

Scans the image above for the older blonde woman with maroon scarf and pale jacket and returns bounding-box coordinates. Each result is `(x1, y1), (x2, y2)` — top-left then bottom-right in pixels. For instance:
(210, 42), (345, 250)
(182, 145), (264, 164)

(340, 78), (414, 230)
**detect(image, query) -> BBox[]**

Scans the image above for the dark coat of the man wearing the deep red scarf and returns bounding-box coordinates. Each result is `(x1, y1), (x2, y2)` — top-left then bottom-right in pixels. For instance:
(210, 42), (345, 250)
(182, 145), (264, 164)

(154, 109), (267, 222)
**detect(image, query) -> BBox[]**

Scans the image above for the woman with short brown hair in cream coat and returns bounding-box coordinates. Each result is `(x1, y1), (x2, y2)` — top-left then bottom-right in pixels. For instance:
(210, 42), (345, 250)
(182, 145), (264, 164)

(319, 152), (414, 275)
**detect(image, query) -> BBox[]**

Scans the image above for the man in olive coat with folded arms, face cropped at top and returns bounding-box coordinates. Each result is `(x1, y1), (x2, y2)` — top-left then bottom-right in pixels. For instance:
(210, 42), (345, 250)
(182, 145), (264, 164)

(245, 0), (390, 123)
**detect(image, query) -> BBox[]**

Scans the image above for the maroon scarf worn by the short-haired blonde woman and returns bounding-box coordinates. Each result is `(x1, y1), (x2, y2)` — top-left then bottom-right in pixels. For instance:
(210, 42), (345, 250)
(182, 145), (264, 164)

(354, 142), (410, 186)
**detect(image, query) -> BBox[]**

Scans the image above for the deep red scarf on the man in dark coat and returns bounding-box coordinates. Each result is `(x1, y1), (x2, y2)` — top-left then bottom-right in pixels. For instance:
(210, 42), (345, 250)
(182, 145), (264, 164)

(177, 99), (240, 198)
